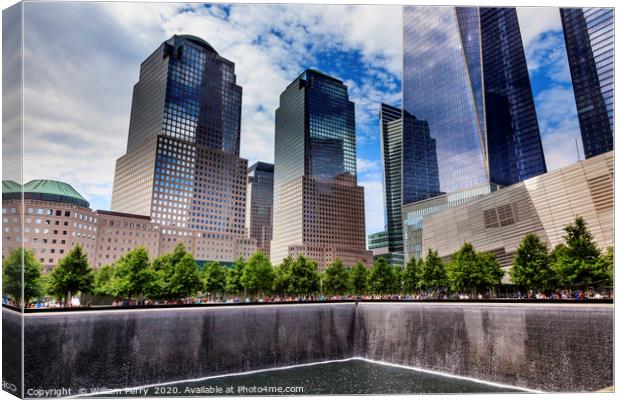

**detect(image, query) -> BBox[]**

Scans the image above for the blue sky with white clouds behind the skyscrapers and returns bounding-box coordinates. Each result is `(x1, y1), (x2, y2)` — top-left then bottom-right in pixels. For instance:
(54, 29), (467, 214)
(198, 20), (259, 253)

(14, 2), (583, 238)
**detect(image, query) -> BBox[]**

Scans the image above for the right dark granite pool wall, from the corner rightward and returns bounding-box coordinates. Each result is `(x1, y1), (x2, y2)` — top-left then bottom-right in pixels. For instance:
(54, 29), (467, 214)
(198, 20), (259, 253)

(356, 303), (613, 391)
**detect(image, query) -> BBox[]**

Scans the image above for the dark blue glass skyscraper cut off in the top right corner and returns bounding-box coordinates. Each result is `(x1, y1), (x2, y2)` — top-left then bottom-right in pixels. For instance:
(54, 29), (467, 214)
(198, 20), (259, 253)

(560, 8), (614, 158)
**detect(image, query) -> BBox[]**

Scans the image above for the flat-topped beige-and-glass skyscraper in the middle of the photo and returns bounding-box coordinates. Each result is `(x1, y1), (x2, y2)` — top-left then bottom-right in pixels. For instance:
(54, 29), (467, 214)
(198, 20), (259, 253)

(271, 70), (372, 268)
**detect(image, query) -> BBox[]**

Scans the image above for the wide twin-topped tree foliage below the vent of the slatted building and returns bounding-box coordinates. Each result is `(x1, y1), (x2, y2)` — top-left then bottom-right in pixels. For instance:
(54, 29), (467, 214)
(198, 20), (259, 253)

(446, 243), (504, 294)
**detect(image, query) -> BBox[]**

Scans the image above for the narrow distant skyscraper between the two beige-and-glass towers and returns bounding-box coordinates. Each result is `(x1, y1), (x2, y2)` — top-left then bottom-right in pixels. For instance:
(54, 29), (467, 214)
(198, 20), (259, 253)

(245, 162), (273, 257)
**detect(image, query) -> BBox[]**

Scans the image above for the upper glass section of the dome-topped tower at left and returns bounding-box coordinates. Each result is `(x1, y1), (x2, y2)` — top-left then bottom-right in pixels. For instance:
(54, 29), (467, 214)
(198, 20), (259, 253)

(127, 35), (241, 155)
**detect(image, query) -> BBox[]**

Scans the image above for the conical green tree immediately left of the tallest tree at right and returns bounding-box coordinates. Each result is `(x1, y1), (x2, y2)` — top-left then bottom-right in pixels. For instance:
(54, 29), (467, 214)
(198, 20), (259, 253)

(510, 233), (557, 292)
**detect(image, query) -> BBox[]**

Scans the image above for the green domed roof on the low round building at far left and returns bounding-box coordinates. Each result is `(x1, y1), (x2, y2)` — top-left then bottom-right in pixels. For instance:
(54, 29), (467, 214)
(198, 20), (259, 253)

(2, 179), (89, 208)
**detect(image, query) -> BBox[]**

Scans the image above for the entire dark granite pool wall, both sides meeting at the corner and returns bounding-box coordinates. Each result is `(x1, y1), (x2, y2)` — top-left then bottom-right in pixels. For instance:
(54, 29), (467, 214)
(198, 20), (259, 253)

(3, 303), (613, 397)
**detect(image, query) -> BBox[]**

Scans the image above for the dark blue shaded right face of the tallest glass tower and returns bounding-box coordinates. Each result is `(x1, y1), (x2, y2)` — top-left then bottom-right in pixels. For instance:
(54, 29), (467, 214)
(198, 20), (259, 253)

(480, 8), (547, 186)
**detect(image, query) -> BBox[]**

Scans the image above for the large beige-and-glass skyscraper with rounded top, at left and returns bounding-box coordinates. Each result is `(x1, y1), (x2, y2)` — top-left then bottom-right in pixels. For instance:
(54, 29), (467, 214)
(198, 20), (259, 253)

(112, 35), (253, 261)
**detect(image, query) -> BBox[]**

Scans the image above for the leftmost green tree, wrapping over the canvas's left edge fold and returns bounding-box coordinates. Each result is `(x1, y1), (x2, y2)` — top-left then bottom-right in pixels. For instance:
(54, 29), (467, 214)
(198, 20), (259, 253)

(2, 248), (43, 306)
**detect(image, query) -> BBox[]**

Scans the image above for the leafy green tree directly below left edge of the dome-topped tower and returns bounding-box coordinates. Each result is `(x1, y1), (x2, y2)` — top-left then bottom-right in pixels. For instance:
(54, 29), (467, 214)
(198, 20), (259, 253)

(114, 247), (158, 300)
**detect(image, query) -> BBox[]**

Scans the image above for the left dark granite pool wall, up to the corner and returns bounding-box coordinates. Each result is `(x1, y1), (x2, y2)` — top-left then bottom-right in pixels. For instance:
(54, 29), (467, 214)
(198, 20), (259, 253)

(25, 304), (355, 393)
